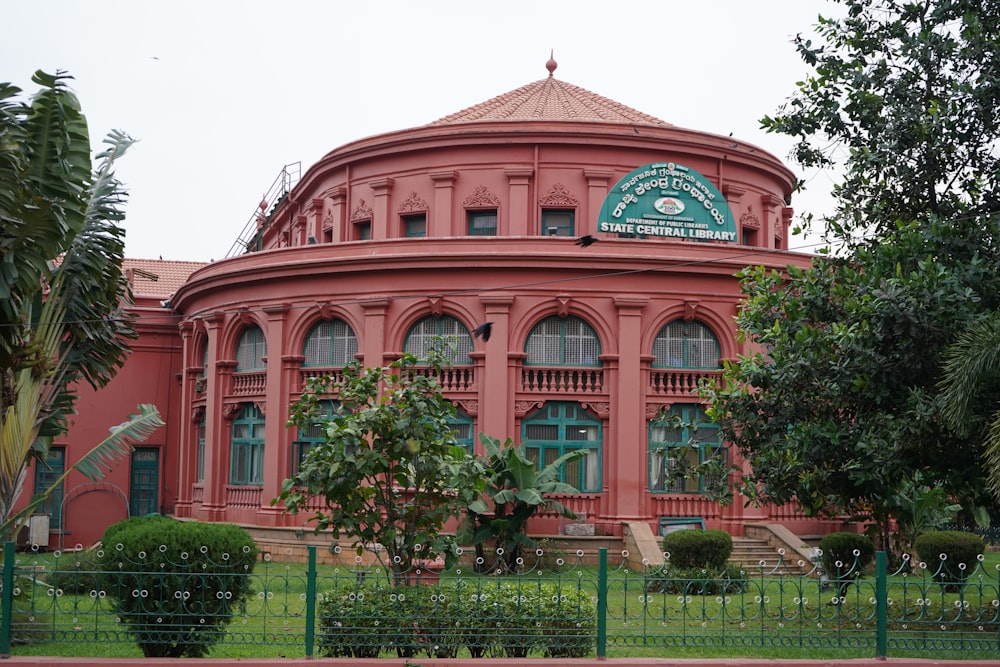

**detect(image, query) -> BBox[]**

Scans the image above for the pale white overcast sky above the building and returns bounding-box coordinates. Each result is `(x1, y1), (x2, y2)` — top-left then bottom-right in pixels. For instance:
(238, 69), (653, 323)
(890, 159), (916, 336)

(0, 0), (841, 261)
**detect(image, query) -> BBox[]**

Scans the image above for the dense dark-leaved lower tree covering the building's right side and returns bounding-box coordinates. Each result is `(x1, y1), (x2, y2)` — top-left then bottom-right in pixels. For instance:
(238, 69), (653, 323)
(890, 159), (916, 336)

(708, 215), (1000, 550)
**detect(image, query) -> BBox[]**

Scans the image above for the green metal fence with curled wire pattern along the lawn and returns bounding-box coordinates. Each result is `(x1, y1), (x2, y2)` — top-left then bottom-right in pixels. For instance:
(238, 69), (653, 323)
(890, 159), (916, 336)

(0, 543), (1000, 657)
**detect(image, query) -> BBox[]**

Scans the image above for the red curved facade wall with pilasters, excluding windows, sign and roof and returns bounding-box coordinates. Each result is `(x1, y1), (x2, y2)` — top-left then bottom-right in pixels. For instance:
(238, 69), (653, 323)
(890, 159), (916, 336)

(164, 117), (815, 534)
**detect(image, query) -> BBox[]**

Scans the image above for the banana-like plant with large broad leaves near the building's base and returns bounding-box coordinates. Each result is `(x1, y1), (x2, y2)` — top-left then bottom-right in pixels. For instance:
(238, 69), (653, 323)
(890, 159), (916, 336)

(464, 433), (587, 572)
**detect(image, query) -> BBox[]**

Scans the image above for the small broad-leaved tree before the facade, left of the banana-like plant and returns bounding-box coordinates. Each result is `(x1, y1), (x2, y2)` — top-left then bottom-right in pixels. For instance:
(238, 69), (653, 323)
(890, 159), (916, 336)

(272, 349), (483, 584)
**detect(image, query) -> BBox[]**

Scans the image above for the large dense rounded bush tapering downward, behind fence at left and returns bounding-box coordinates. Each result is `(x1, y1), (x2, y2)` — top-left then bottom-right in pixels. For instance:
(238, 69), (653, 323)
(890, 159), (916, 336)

(98, 516), (257, 658)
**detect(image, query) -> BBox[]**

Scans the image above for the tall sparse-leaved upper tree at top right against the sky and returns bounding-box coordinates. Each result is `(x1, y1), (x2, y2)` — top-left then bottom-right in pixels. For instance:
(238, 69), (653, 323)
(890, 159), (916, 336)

(762, 0), (1000, 240)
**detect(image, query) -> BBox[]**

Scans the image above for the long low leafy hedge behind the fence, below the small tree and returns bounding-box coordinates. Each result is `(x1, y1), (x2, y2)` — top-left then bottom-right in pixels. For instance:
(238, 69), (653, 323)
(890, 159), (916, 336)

(319, 580), (597, 658)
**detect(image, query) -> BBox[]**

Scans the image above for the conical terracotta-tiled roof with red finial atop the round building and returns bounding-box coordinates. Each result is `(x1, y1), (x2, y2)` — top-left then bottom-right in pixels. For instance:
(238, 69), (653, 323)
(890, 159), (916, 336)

(428, 53), (670, 127)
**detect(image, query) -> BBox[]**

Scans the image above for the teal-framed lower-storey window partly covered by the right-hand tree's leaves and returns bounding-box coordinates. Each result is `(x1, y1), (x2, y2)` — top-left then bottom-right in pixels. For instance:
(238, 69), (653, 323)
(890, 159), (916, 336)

(649, 403), (728, 493)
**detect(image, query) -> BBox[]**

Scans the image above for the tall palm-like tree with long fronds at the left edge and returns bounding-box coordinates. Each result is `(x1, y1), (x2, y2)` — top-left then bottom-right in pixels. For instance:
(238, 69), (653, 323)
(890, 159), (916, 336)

(0, 72), (162, 535)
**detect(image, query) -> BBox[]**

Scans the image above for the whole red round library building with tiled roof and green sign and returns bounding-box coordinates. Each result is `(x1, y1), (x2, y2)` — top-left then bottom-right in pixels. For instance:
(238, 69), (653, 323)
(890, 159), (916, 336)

(25, 61), (821, 543)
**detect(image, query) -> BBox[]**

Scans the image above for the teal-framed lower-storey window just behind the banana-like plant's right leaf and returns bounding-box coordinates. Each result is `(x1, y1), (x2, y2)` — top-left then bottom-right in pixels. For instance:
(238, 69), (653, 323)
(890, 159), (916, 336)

(521, 401), (603, 493)
